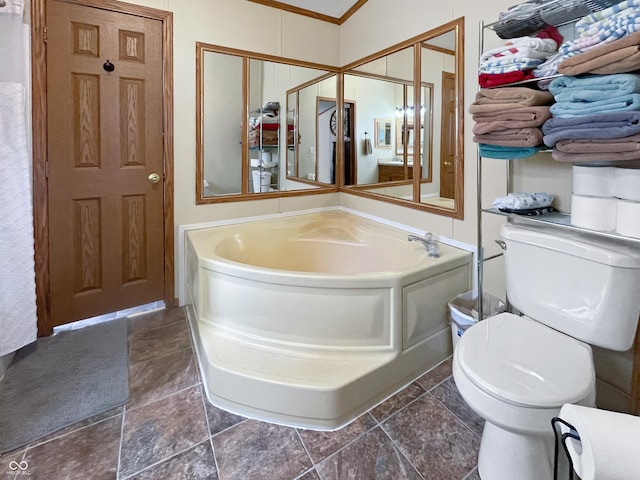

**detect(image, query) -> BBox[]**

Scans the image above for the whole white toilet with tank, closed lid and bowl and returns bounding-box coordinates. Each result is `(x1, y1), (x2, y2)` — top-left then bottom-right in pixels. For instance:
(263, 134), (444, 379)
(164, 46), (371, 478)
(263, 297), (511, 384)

(453, 224), (640, 480)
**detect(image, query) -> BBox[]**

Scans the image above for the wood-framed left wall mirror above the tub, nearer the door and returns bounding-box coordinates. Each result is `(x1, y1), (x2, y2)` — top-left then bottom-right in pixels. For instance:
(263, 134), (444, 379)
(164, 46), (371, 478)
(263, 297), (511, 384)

(196, 43), (337, 203)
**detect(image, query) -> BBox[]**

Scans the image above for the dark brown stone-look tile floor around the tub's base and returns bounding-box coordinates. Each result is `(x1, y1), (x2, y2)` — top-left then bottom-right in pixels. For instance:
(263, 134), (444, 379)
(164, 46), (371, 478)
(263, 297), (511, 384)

(0, 308), (482, 480)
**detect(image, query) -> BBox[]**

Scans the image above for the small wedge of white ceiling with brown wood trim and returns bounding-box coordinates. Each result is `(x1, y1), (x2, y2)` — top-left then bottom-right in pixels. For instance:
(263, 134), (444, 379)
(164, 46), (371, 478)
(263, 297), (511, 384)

(249, 0), (367, 25)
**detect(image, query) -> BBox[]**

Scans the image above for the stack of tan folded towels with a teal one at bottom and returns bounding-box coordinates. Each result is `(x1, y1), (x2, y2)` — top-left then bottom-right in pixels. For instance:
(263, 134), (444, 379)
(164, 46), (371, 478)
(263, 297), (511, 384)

(469, 87), (553, 158)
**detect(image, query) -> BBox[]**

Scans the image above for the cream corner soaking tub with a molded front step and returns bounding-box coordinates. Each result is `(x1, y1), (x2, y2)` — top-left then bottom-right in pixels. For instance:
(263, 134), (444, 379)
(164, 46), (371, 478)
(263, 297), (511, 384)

(185, 211), (472, 430)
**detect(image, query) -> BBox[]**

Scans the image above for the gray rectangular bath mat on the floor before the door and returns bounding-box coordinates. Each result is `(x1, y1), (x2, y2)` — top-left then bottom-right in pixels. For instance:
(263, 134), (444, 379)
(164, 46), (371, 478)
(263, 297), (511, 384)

(0, 319), (129, 453)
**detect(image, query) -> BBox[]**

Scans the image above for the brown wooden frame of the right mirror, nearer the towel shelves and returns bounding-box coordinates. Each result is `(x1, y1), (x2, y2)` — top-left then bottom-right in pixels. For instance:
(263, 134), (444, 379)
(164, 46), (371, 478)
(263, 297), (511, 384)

(339, 17), (465, 219)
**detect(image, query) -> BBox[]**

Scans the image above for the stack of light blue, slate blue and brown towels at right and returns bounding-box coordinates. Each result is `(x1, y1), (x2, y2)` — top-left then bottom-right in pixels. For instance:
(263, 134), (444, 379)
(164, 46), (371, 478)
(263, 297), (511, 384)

(542, 73), (640, 163)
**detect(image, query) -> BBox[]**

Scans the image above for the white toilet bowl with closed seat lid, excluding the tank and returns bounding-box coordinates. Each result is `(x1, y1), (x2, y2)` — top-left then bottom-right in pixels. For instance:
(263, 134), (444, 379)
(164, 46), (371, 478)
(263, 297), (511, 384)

(453, 313), (595, 480)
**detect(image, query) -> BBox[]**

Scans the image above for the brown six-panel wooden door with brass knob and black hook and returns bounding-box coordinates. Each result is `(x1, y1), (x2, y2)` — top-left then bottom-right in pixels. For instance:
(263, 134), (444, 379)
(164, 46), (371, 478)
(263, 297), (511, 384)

(46, 0), (165, 326)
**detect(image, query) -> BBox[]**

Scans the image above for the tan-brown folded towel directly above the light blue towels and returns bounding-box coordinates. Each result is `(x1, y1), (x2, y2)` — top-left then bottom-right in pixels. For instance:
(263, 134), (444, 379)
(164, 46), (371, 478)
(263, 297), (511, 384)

(558, 32), (640, 75)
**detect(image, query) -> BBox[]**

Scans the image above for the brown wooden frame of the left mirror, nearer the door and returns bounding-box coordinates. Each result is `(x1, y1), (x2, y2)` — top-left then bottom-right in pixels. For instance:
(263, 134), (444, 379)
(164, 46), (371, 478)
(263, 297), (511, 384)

(195, 42), (340, 205)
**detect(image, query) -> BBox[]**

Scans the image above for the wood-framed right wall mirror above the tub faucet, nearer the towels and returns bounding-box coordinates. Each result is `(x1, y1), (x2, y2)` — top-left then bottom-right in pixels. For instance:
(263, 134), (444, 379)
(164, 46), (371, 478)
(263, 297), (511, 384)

(344, 18), (464, 218)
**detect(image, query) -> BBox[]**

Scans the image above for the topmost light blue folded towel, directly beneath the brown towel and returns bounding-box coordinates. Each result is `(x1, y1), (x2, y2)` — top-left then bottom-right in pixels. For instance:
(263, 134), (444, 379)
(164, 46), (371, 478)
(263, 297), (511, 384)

(549, 73), (640, 102)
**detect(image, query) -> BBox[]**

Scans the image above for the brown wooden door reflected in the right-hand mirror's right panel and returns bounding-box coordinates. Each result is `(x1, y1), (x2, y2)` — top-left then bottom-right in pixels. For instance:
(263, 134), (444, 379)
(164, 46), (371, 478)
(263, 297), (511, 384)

(440, 72), (457, 198)
